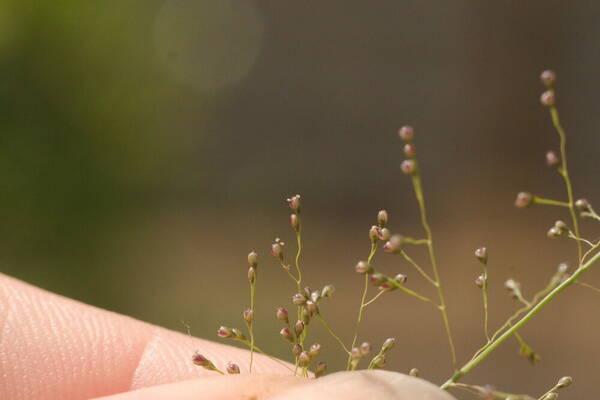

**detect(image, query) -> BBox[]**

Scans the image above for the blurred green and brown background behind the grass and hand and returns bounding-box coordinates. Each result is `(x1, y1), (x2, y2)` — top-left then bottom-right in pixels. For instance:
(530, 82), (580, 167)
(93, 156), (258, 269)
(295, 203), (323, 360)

(0, 0), (600, 398)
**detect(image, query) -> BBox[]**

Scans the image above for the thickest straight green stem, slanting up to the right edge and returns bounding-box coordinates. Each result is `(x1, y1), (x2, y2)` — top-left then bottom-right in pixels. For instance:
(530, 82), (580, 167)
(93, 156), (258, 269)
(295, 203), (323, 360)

(441, 253), (600, 389)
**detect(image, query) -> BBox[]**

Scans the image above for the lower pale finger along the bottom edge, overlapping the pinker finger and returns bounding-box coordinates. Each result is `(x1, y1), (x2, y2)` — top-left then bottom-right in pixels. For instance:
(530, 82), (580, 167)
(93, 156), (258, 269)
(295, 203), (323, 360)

(96, 370), (454, 400)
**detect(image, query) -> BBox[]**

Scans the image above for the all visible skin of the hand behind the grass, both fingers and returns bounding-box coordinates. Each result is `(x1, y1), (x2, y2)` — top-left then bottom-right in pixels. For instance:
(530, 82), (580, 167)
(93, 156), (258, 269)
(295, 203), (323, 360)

(0, 274), (453, 400)
